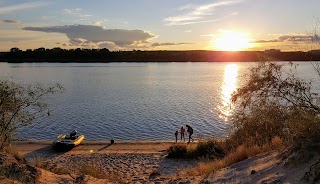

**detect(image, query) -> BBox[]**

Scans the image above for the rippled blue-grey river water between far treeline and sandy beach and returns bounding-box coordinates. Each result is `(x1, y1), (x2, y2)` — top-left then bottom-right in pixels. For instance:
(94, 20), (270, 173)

(0, 63), (317, 140)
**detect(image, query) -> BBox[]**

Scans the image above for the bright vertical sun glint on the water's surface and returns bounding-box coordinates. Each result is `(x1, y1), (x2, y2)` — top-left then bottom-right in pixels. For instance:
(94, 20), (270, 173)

(219, 64), (238, 121)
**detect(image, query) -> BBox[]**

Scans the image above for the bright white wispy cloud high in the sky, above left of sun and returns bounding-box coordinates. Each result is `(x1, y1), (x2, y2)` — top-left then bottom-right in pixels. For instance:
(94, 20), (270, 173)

(164, 0), (241, 25)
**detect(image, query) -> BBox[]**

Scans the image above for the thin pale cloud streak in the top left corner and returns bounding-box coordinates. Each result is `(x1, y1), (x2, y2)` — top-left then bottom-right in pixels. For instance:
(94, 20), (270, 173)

(0, 1), (49, 14)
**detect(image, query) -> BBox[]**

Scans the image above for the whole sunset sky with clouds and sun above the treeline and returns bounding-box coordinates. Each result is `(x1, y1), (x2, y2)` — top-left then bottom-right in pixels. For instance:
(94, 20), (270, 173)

(0, 0), (320, 51)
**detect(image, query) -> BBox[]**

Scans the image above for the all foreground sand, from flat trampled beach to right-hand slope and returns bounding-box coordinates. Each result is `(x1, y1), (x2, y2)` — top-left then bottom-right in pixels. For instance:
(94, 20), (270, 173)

(13, 141), (320, 184)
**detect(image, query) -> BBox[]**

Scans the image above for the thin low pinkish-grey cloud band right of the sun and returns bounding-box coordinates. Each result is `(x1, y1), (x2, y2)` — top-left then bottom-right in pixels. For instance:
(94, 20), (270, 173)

(255, 35), (320, 43)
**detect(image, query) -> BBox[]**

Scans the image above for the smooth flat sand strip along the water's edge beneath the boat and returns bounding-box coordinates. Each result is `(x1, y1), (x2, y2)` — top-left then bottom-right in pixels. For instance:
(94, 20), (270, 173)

(11, 140), (190, 160)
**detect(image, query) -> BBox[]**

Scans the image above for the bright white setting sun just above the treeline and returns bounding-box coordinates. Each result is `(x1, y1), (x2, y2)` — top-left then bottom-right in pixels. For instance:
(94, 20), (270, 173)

(213, 31), (251, 51)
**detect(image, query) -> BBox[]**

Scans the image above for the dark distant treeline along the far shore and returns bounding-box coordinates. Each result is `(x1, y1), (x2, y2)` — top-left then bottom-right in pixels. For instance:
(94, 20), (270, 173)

(0, 48), (320, 63)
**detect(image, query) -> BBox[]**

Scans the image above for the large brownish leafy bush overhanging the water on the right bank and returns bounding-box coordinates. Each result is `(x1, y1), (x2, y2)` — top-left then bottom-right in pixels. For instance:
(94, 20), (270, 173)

(228, 63), (320, 148)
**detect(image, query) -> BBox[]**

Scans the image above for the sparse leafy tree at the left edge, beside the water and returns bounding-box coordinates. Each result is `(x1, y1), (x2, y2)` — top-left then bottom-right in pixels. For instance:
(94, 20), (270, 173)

(0, 79), (63, 150)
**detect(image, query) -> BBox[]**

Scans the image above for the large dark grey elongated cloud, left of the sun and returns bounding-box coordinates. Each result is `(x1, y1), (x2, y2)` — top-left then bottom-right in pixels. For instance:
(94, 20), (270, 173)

(22, 25), (155, 47)
